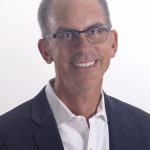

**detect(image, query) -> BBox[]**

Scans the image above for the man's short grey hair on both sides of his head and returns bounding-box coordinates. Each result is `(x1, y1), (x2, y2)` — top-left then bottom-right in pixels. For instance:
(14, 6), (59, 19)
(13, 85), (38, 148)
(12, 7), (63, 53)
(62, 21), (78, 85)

(38, 0), (112, 37)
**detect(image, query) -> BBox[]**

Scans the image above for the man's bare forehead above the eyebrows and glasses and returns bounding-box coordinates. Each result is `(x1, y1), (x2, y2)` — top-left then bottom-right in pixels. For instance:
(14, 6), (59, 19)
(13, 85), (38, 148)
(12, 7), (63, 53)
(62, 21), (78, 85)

(51, 0), (106, 30)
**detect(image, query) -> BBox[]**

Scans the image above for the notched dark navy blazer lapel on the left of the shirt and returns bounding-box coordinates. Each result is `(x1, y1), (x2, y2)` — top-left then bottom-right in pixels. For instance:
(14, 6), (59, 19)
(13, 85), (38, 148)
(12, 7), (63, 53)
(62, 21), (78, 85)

(32, 88), (64, 150)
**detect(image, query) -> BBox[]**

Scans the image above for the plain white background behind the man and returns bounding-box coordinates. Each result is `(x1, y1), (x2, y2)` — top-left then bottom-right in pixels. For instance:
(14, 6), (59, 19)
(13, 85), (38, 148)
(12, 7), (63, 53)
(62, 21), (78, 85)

(0, 0), (150, 114)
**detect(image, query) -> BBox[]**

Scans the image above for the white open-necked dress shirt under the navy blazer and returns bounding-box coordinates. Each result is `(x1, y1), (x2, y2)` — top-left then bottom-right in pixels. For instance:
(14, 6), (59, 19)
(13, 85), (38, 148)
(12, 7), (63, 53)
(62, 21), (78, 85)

(45, 83), (109, 150)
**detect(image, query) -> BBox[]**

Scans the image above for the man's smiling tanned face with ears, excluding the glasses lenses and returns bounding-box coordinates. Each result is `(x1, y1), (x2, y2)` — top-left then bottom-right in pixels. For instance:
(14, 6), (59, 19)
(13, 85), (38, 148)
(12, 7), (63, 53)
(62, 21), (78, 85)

(39, 0), (117, 91)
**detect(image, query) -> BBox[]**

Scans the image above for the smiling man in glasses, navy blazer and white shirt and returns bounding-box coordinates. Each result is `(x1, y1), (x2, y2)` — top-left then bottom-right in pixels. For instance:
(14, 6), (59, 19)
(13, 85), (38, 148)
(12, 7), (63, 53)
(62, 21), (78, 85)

(0, 0), (150, 150)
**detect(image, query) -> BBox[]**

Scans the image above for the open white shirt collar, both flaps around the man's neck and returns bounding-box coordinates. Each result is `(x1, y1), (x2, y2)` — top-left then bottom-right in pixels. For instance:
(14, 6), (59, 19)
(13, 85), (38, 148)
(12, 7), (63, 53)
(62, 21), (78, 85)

(45, 81), (107, 125)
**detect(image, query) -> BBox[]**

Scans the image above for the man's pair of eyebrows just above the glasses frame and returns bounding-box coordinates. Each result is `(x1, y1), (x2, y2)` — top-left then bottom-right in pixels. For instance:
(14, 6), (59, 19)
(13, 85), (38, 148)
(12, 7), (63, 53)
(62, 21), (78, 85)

(56, 22), (106, 33)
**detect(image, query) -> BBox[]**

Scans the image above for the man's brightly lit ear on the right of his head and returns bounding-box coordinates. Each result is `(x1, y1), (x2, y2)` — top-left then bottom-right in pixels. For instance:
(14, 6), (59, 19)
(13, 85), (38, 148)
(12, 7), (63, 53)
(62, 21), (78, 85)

(110, 30), (118, 58)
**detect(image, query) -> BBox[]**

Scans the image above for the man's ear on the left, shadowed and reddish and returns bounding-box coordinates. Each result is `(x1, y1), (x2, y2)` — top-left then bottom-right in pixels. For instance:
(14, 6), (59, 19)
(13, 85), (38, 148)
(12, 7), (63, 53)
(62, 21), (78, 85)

(38, 39), (53, 64)
